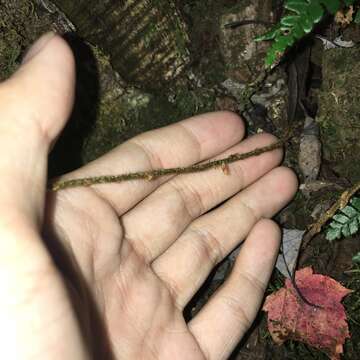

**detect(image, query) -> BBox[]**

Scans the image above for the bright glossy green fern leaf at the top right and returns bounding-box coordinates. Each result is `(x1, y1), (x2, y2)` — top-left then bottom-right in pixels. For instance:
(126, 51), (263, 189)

(255, 0), (356, 68)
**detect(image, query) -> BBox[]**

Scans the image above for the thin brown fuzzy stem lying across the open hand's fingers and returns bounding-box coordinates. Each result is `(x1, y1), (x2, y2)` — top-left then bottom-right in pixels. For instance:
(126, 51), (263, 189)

(49, 136), (289, 191)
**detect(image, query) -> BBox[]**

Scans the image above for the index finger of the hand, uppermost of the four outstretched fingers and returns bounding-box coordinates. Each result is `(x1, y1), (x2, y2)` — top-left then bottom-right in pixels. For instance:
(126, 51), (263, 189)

(54, 111), (245, 215)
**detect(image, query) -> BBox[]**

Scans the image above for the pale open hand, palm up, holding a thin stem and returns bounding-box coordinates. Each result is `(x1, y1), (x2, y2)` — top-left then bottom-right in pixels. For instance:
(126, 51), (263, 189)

(0, 34), (297, 360)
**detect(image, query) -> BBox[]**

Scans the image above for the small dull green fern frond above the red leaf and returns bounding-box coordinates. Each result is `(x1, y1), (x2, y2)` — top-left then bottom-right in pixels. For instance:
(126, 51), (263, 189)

(326, 197), (360, 241)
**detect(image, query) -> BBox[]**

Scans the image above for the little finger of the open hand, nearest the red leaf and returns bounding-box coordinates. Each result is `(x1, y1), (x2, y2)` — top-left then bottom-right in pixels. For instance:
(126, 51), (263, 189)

(189, 219), (280, 359)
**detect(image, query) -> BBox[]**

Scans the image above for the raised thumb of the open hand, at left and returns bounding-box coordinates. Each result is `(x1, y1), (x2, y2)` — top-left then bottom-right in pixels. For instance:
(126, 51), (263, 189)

(0, 33), (75, 227)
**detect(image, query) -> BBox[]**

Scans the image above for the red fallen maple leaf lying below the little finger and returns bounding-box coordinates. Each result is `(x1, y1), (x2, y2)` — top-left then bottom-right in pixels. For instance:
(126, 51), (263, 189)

(263, 267), (351, 360)
